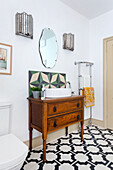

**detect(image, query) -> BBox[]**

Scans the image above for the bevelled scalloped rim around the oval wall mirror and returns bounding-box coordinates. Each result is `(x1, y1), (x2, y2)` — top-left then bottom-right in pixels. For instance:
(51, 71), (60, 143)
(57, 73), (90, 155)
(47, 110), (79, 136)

(39, 28), (58, 69)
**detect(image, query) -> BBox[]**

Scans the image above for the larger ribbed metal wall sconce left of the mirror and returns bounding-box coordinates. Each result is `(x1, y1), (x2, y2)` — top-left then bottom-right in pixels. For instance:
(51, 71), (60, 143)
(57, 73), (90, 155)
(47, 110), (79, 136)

(16, 12), (33, 39)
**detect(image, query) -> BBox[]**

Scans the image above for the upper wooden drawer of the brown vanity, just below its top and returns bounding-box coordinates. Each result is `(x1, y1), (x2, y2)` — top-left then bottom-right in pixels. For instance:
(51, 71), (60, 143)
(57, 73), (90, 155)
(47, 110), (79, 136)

(48, 99), (83, 115)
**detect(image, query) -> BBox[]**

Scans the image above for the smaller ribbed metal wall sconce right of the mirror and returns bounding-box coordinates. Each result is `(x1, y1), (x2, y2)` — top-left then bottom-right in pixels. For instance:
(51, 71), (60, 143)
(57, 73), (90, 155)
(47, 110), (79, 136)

(63, 33), (74, 51)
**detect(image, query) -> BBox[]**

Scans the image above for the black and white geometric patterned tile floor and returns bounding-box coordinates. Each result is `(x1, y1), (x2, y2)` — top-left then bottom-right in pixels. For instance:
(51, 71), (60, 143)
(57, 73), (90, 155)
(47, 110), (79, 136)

(21, 125), (113, 170)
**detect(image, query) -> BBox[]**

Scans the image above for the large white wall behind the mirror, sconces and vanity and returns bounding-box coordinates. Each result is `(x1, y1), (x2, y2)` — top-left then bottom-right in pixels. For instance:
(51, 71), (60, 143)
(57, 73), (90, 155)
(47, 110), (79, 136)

(0, 0), (89, 141)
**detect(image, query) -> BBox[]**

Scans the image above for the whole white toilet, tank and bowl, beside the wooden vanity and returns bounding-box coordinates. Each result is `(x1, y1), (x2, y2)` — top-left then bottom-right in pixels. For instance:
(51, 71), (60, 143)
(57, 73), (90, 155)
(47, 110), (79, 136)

(0, 103), (28, 170)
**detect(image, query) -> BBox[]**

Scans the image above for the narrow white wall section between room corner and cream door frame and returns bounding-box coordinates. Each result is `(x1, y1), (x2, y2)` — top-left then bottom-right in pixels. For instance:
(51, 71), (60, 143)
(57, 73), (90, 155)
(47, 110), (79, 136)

(90, 11), (113, 120)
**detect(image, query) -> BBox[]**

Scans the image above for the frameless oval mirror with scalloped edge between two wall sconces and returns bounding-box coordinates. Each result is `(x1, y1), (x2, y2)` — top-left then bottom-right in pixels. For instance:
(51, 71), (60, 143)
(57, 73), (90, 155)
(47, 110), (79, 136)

(39, 28), (58, 68)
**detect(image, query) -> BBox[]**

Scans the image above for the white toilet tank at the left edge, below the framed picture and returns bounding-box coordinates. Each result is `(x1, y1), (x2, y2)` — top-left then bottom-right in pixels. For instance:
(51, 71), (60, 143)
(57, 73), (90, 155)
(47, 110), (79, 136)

(0, 102), (11, 136)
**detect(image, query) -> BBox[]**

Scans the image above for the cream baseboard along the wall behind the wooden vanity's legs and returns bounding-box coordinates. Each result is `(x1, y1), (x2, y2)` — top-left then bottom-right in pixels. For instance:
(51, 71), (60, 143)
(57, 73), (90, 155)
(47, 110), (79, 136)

(24, 119), (89, 148)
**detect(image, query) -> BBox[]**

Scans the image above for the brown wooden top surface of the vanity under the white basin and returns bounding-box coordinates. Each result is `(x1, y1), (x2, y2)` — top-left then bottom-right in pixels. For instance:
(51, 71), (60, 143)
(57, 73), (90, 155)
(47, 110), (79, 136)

(28, 95), (84, 103)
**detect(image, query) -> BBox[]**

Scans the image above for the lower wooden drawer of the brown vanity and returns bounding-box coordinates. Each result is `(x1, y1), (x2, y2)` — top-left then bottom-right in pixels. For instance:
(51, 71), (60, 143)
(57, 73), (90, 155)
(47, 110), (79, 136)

(47, 111), (82, 131)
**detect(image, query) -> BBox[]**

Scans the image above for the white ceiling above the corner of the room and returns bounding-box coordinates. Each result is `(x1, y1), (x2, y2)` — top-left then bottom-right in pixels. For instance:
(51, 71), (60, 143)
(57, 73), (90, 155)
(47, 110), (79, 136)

(61, 0), (113, 19)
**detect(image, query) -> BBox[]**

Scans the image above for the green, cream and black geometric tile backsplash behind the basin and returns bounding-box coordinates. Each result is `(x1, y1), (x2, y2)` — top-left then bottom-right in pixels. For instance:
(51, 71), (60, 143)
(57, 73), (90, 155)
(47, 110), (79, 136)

(29, 71), (66, 96)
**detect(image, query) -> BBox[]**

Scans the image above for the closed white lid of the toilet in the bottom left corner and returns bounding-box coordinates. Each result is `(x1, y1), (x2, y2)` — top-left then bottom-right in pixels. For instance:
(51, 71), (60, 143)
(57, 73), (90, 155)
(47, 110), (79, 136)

(0, 134), (28, 170)
